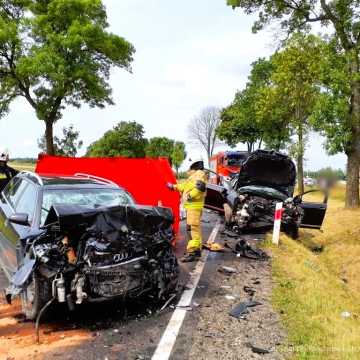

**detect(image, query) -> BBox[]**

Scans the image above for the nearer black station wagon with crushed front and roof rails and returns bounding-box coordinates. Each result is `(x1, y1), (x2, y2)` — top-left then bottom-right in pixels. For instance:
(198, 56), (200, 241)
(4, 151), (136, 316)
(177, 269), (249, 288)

(0, 172), (179, 319)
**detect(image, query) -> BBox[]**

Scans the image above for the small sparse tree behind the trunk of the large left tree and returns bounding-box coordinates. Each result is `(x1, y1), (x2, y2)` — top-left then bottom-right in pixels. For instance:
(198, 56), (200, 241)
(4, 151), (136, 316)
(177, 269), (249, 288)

(38, 125), (83, 156)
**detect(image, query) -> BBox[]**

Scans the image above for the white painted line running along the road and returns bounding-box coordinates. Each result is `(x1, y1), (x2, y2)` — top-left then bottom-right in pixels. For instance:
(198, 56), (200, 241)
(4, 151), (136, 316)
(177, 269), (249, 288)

(151, 222), (220, 360)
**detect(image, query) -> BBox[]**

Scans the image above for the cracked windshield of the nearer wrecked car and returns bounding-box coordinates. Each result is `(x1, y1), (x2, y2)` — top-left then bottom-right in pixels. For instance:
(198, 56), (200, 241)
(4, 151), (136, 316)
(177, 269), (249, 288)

(41, 189), (134, 224)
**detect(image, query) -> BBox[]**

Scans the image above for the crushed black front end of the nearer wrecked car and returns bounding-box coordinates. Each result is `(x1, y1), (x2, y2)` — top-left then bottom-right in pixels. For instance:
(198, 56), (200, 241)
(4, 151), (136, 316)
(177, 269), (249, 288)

(7, 205), (179, 319)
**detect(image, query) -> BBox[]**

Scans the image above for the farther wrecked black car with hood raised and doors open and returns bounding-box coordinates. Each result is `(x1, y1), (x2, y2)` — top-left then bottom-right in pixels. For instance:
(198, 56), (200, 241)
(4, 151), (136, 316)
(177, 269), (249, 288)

(205, 150), (328, 238)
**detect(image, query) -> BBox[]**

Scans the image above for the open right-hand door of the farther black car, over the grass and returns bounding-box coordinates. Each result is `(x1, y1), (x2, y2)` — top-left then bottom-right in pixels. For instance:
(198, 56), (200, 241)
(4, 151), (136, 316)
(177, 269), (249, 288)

(299, 190), (329, 229)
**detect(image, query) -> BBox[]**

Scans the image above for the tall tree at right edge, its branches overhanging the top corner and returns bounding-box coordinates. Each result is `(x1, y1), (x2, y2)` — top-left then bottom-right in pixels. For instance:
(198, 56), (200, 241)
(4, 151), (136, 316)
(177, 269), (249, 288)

(227, 0), (360, 207)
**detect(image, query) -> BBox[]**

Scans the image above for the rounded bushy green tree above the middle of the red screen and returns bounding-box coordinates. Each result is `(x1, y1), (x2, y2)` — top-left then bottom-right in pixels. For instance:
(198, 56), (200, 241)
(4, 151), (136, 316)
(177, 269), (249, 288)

(86, 121), (147, 158)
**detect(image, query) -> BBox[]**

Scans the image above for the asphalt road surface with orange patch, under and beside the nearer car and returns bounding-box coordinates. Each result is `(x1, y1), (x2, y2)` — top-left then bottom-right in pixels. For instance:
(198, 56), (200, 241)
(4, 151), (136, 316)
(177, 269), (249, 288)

(0, 213), (222, 360)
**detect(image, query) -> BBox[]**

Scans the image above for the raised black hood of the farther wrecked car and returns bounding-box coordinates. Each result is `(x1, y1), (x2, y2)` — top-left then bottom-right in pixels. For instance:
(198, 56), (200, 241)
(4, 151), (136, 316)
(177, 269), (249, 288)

(236, 150), (296, 197)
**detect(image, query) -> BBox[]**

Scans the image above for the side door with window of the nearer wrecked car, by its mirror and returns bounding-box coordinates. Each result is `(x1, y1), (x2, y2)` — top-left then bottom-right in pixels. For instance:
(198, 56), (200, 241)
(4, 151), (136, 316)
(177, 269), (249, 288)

(0, 178), (37, 278)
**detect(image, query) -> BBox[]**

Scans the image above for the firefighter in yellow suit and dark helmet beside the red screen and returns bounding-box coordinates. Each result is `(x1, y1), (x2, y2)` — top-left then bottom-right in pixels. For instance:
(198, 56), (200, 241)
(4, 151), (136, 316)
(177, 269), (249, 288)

(167, 159), (208, 262)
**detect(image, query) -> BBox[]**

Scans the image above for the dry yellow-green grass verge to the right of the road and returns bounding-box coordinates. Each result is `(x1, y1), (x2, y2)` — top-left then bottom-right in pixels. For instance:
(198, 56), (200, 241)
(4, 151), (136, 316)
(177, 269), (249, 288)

(272, 186), (360, 360)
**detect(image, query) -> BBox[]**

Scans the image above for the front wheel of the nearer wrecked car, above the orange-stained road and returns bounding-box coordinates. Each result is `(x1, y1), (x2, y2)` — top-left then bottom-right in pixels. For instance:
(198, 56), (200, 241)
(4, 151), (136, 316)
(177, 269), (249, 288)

(21, 274), (50, 320)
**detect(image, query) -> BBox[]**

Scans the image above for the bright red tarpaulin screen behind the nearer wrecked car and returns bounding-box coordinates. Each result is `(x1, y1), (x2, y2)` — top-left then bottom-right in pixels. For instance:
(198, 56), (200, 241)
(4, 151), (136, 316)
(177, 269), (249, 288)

(35, 154), (180, 232)
